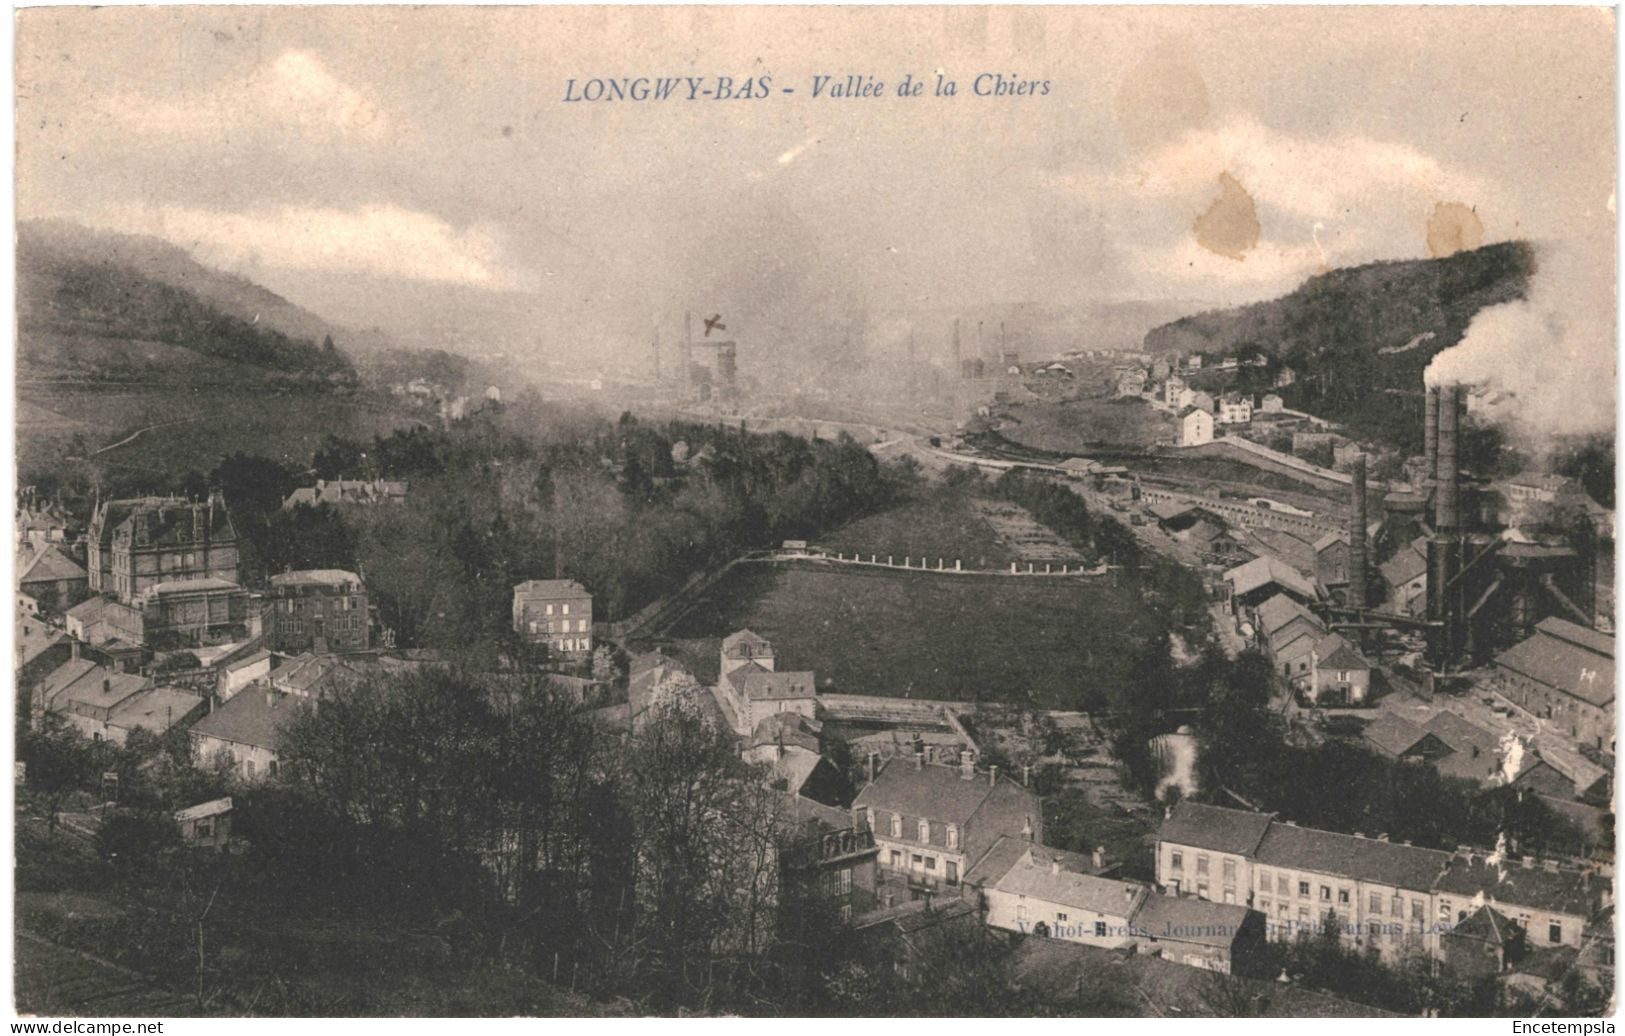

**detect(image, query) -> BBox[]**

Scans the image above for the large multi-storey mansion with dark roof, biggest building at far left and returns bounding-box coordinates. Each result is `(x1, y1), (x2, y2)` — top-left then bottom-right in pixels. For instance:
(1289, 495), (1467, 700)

(86, 490), (237, 606)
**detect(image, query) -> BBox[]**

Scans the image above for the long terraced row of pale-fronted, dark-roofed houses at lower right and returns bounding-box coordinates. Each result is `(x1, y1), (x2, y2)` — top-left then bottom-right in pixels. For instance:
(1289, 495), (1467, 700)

(1157, 801), (1614, 987)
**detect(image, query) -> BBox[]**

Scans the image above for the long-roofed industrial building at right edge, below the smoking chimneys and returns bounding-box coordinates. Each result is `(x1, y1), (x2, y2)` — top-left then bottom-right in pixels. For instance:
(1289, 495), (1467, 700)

(1495, 617), (1614, 752)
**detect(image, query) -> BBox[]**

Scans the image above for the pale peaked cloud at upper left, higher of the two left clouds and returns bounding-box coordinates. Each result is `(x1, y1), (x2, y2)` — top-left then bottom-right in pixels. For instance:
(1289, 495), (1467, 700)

(99, 50), (392, 141)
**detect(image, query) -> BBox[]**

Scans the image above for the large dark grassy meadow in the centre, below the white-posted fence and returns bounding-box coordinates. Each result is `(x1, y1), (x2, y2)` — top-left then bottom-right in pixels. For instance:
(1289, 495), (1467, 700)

(666, 563), (1151, 708)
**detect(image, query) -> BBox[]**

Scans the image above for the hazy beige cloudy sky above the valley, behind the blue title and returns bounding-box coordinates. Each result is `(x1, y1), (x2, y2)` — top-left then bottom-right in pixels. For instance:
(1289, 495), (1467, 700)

(16, 6), (1615, 371)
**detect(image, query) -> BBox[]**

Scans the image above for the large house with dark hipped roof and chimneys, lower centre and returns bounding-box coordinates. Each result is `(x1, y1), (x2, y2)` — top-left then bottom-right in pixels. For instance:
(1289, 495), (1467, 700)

(853, 752), (1043, 888)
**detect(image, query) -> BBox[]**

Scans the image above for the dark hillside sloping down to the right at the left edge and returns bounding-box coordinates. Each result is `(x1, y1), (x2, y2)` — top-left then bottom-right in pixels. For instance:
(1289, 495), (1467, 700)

(16, 221), (356, 386)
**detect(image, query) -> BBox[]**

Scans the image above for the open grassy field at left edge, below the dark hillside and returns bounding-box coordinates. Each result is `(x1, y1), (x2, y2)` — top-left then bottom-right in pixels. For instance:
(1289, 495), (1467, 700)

(18, 385), (422, 481)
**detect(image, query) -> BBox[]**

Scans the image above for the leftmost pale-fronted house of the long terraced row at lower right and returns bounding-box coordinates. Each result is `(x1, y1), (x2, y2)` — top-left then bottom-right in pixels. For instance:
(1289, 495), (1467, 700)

(1157, 799), (1272, 904)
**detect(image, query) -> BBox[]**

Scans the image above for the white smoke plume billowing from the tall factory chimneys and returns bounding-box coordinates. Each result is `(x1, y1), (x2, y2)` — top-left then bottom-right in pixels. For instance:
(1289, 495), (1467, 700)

(1425, 247), (1617, 456)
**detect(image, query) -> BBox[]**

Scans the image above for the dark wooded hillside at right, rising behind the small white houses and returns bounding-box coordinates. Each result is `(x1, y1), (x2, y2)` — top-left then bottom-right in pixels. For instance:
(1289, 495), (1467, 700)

(1146, 242), (1536, 450)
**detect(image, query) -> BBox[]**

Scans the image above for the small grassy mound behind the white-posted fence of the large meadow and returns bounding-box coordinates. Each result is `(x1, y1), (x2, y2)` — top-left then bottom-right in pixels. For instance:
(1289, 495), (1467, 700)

(817, 489), (1016, 568)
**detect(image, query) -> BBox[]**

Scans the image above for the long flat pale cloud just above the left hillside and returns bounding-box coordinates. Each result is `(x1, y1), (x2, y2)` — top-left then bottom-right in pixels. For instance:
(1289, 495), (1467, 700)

(98, 205), (512, 289)
